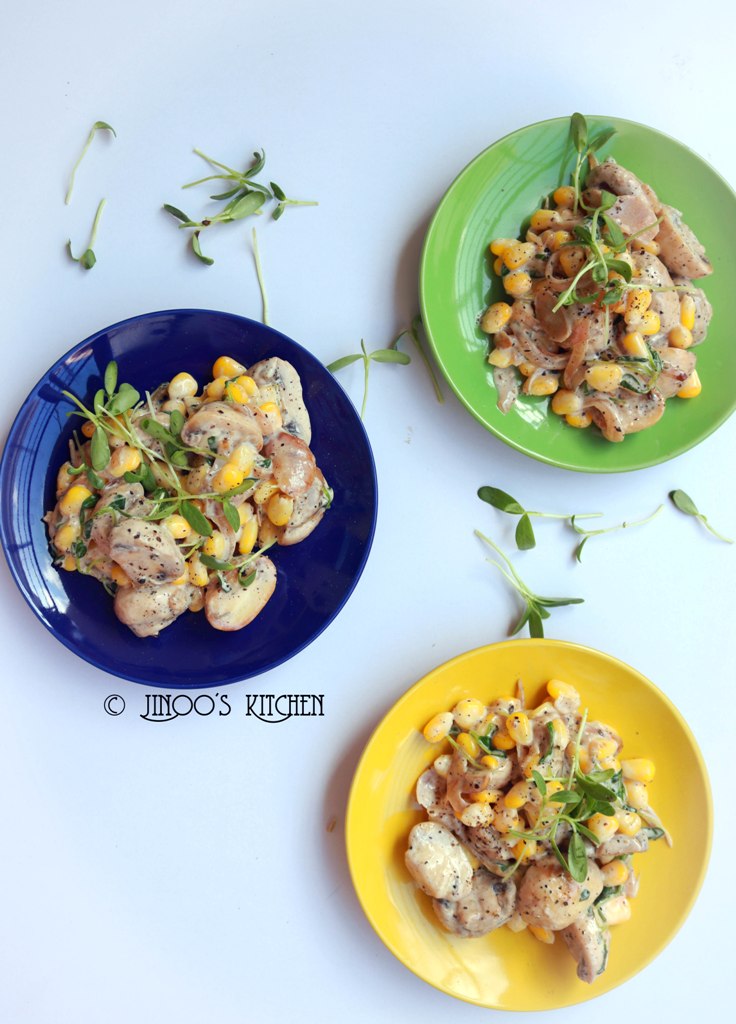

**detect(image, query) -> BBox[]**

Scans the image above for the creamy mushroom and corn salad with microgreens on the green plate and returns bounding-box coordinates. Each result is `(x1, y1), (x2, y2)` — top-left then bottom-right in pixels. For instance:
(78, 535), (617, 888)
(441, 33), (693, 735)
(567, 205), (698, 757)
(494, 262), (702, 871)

(480, 114), (712, 441)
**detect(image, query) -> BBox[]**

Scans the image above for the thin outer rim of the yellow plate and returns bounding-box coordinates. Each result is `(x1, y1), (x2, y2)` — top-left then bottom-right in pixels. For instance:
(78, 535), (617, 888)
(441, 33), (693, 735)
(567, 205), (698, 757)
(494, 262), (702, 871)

(345, 637), (713, 1013)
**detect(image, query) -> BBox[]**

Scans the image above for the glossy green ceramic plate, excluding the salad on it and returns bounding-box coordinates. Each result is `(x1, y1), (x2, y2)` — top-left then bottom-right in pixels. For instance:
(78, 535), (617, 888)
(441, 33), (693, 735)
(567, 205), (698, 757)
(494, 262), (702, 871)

(420, 117), (736, 473)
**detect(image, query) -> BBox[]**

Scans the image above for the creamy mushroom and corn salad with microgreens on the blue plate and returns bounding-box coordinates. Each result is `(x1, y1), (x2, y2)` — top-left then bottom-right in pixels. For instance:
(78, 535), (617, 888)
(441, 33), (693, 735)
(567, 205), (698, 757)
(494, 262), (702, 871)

(44, 355), (333, 637)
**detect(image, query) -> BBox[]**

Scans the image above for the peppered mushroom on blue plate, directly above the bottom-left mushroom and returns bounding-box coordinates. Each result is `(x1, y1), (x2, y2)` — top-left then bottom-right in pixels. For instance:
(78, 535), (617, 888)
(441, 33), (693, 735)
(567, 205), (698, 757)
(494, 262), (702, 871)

(110, 518), (185, 584)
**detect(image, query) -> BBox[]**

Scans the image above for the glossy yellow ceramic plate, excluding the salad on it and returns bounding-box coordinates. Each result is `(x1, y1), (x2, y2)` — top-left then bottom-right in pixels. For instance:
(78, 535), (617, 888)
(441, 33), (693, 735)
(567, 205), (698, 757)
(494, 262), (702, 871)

(346, 640), (712, 1010)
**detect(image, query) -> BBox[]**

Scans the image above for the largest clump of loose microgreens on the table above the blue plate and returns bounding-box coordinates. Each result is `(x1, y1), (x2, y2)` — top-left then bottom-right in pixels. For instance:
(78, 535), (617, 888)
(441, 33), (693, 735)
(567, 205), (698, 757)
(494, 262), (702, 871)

(164, 150), (318, 268)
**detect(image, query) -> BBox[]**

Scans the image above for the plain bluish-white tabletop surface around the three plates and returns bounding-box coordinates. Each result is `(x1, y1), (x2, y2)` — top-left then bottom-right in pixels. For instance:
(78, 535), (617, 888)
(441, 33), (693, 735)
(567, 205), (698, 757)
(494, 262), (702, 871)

(0, 0), (736, 1024)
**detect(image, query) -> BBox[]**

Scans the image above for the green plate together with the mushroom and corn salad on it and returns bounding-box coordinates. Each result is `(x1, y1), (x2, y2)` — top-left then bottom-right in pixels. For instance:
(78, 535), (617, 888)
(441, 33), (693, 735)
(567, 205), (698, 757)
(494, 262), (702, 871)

(420, 115), (736, 472)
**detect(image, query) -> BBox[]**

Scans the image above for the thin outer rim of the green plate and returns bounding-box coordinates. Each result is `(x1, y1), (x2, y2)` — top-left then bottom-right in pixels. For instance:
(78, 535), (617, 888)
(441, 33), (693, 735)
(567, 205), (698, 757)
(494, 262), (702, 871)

(419, 114), (736, 475)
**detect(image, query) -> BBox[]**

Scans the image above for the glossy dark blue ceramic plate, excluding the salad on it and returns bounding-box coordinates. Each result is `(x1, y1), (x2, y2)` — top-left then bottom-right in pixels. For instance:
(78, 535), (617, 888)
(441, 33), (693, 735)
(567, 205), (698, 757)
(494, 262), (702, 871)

(0, 309), (377, 688)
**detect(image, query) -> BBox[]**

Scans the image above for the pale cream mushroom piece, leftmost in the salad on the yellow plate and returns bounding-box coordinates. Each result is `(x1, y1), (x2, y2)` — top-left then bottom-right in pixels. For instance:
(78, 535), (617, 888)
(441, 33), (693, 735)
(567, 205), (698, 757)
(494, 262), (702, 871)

(404, 821), (473, 900)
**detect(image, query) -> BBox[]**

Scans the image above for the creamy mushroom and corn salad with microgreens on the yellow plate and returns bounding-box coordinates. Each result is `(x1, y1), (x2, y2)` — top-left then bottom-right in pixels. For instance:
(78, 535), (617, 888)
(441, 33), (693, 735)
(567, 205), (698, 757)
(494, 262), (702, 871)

(405, 679), (672, 983)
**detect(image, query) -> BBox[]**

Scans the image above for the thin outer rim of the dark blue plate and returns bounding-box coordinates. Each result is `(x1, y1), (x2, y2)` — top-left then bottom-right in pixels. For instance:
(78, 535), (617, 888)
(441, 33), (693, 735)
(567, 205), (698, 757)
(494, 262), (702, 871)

(0, 306), (379, 692)
